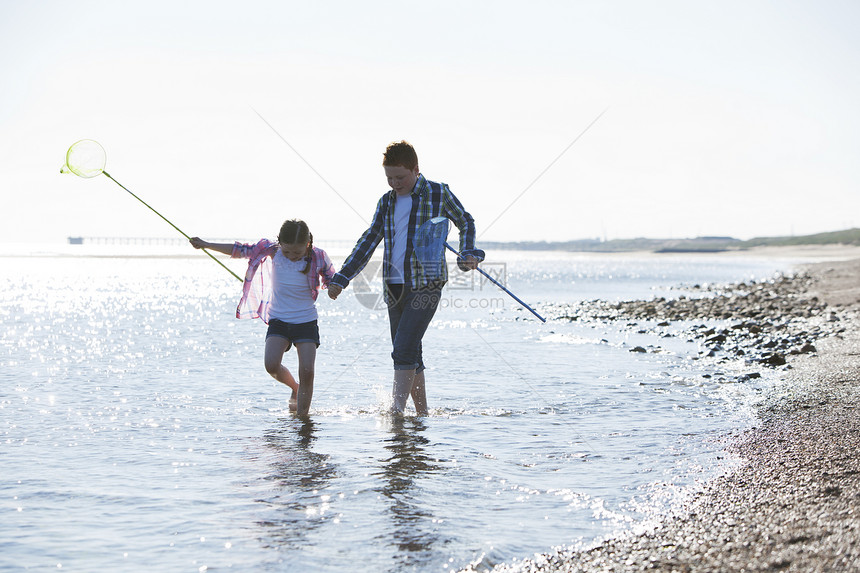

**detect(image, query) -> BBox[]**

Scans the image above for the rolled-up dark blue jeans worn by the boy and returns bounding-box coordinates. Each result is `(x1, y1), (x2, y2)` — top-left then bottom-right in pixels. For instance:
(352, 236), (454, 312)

(385, 284), (442, 372)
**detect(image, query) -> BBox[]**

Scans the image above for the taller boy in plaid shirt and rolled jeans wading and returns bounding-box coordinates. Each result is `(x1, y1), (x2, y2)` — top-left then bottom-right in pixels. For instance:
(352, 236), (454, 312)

(328, 141), (484, 416)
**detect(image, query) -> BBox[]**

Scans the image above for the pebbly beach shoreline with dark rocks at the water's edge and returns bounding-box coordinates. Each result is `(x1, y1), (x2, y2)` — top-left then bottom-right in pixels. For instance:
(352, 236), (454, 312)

(474, 259), (860, 573)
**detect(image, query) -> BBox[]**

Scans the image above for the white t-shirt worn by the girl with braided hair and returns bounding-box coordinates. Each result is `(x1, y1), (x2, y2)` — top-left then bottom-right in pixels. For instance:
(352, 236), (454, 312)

(269, 249), (317, 324)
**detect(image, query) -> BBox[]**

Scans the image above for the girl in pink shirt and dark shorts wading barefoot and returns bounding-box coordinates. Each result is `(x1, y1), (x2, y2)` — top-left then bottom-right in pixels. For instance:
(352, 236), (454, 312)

(191, 219), (334, 416)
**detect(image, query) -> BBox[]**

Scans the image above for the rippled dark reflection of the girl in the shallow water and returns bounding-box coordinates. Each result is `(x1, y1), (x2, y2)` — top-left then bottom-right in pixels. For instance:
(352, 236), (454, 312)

(257, 417), (338, 549)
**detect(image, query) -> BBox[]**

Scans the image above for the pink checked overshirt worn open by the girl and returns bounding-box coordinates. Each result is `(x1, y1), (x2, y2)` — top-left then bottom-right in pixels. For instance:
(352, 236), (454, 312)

(230, 239), (334, 324)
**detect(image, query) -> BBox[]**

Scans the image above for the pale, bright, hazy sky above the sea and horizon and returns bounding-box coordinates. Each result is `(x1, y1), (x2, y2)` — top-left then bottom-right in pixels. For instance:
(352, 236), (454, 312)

(0, 0), (860, 242)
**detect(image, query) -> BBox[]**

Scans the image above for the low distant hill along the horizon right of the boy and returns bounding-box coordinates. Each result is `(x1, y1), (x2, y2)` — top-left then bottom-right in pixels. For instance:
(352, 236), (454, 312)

(481, 229), (860, 253)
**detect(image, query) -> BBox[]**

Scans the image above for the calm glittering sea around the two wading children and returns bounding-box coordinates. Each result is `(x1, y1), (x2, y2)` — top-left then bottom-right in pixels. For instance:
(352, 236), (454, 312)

(0, 245), (828, 572)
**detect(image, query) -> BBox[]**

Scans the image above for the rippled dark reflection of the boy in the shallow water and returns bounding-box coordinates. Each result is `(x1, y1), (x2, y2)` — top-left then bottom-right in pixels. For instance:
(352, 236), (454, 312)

(376, 418), (446, 571)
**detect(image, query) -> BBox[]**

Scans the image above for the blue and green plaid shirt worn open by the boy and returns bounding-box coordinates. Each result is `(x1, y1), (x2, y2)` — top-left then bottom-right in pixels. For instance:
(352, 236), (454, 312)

(331, 174), (484, 289)
